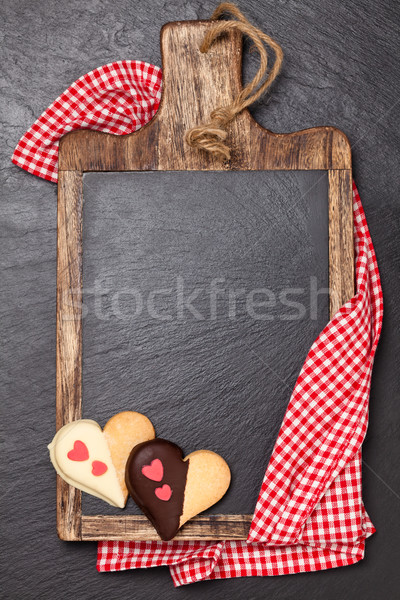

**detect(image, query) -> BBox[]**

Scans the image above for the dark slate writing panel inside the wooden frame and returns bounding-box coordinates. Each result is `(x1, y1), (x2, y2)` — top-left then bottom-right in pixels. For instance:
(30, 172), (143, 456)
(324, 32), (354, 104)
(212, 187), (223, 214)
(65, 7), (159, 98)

(83, 171), (329, 514)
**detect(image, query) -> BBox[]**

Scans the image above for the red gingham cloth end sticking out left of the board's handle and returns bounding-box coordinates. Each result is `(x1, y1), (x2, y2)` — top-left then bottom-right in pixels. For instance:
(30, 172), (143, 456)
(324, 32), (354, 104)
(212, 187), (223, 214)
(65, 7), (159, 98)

(11, 60), (162, 183)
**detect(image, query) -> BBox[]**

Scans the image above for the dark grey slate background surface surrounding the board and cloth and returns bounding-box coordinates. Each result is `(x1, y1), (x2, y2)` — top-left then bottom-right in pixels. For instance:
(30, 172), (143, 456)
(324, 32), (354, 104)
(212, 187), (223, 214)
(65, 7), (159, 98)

(0, 0), (400, 600)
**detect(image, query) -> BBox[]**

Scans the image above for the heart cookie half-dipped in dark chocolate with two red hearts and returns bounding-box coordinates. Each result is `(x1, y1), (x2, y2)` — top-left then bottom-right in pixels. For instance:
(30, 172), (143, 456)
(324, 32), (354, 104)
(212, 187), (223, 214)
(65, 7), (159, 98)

(125, 438), (231, 541)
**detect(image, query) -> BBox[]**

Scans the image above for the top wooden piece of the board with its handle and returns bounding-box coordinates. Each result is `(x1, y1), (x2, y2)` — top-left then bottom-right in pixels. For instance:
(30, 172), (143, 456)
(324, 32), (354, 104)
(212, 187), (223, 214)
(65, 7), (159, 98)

(59, 21), (351, 171)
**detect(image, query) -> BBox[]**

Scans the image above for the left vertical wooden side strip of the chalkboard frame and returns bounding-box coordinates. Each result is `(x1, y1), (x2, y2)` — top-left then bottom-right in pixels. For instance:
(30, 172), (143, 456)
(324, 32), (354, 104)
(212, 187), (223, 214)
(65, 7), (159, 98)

(56, 171), (83, 540)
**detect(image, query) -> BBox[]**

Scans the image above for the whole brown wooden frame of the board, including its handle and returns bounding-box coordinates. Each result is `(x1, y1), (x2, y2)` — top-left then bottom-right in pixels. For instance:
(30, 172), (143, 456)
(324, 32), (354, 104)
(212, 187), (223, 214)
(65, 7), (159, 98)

(56, 21), (354, 540)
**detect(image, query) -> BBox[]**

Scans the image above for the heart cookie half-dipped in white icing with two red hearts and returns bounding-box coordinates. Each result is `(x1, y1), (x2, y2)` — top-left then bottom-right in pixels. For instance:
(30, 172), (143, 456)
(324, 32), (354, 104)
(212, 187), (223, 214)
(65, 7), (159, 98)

(48, 411), (155, 508)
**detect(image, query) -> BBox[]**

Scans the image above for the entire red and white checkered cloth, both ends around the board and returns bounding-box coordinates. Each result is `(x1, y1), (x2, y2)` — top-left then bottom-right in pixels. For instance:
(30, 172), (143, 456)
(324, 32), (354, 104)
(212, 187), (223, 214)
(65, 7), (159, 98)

(12, 61), (383, 586)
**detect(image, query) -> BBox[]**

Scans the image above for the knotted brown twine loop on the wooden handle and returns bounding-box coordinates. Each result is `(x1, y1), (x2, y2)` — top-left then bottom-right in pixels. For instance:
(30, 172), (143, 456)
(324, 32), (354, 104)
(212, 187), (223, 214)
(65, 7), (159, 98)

(185, 2), (283, 160)
